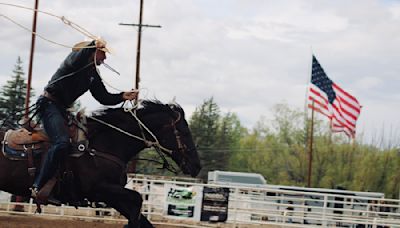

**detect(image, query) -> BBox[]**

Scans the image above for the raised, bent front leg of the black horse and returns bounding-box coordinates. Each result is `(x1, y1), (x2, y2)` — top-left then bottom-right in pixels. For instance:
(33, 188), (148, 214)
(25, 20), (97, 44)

(94, 183), (153, 228)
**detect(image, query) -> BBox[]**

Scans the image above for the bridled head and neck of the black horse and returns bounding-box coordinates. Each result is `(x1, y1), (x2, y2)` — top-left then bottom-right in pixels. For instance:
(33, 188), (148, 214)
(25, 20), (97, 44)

(91, 100), (201, 177)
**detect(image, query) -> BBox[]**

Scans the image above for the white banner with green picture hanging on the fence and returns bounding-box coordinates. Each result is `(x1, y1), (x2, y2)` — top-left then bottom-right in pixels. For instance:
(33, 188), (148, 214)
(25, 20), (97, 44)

(164, 184), (203, 221)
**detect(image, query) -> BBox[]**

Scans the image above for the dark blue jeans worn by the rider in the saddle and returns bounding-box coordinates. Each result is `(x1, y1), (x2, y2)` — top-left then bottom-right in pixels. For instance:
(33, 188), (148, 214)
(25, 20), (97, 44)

(33, 97), (71, 189)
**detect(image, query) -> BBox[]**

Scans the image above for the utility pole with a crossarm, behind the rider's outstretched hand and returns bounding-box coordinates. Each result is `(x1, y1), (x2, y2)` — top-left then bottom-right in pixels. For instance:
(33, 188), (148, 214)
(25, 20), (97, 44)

(119, 0), (161, 173)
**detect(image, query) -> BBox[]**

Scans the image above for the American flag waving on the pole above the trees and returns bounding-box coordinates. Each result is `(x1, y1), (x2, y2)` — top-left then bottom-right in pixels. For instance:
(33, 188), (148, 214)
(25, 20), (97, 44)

(308, 55), (361, 138)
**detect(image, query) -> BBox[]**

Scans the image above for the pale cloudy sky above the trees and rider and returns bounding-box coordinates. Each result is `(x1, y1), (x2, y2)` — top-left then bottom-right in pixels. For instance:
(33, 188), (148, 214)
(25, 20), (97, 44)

(0, 0), (400, 146)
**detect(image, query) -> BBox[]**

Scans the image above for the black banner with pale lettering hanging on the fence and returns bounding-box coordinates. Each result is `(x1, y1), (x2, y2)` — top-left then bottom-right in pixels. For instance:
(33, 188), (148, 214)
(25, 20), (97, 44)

(200, 187), (229, 222)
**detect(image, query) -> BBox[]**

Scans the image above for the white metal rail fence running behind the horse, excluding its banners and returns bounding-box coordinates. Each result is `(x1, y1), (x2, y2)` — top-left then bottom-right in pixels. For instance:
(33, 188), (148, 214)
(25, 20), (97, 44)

(0, 176), (400, 228)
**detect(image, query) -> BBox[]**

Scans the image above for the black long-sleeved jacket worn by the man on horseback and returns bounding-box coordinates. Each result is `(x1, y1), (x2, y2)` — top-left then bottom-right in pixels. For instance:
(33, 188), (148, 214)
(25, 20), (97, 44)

(45, 42), (123, 107)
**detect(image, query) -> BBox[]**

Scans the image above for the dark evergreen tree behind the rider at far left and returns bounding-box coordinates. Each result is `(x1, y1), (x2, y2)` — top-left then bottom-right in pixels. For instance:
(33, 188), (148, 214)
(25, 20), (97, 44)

(0, 57), (34, 128)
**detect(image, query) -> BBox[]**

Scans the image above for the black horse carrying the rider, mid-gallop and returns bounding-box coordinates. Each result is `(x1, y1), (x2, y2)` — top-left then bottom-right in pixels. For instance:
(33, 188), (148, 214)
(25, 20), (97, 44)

(0, 101), (201, 228)
